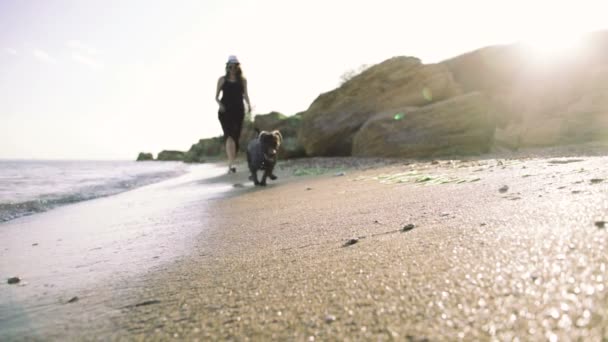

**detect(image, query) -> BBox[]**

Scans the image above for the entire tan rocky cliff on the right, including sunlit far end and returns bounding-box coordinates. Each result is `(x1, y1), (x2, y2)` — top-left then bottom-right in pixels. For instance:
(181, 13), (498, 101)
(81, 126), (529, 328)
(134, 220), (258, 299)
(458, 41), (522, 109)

(298, 32), (608, 157)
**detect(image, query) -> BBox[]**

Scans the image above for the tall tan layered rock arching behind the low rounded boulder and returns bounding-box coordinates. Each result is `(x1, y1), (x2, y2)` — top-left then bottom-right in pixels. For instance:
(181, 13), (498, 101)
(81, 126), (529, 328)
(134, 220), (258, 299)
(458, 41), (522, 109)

(298, 57), (461, 156)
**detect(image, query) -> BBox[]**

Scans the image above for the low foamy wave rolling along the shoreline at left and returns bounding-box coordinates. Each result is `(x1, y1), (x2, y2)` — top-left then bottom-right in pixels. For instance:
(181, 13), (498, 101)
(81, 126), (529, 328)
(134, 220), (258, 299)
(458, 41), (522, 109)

(0, 170), (186, 223)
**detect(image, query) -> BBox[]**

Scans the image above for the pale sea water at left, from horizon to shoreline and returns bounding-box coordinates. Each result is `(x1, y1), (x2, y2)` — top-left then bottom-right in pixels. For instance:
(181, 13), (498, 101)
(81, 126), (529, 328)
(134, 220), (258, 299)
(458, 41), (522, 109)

(0, 160), (187, 223)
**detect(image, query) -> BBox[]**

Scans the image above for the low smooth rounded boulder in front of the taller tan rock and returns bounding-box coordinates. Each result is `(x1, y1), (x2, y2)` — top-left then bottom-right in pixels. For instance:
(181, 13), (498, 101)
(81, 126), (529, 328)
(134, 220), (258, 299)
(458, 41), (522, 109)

(353, 92), (496, 157)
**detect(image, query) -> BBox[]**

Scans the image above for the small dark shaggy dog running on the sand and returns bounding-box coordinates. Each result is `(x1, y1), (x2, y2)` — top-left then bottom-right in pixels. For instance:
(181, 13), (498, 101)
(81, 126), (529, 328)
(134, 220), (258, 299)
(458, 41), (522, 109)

(247, 130), (283, 186)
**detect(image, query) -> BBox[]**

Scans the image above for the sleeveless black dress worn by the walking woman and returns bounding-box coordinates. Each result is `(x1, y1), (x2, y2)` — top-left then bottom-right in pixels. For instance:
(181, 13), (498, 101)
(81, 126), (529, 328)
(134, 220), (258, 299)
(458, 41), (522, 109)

(218, 78), (245, 151)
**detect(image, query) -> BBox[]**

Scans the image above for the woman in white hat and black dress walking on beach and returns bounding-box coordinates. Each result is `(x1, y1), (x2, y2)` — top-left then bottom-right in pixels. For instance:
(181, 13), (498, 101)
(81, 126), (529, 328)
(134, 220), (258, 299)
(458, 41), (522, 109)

(215, 56), (251, 173)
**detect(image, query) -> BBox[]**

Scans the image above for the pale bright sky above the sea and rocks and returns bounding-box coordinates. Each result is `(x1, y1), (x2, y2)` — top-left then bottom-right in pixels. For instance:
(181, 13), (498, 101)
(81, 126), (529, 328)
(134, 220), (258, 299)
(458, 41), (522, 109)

(0, 0), (608, 160)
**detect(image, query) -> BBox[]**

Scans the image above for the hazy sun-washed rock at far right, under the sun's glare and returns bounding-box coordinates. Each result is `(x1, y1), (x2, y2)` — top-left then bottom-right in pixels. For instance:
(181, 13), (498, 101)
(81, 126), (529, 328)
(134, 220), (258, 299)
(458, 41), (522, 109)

(443, 32), (608, 149)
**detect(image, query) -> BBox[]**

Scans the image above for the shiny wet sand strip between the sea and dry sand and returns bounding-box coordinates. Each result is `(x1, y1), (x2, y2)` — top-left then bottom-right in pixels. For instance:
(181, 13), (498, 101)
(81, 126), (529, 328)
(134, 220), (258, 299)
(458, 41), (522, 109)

(0, 165), (232, 340)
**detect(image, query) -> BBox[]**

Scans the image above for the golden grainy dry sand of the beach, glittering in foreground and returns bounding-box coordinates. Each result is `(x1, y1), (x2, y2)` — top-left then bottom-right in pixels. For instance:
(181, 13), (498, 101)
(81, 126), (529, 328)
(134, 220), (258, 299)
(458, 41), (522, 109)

(2, 149), (608, 341)
